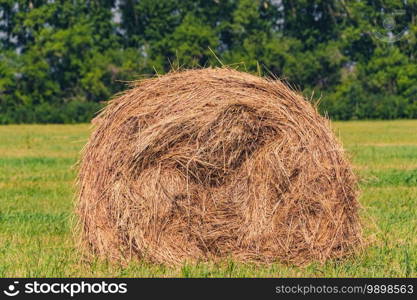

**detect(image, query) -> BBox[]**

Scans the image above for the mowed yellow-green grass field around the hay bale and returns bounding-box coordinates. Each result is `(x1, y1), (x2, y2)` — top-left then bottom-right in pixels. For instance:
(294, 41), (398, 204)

(0, 121), (417, 277)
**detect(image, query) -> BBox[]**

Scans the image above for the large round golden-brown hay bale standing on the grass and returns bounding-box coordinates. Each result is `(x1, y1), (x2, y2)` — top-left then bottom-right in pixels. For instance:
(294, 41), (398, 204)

(76, 68), (361, 264)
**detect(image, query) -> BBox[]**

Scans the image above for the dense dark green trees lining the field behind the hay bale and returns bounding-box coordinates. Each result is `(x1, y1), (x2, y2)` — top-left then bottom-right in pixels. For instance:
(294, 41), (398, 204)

(0, 0), (417, 124)
